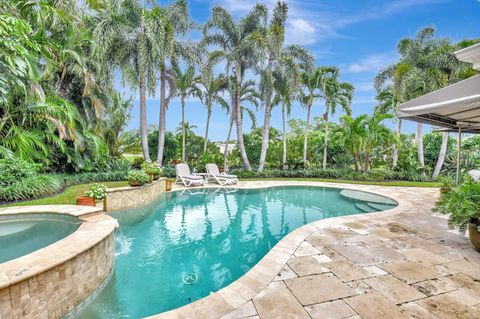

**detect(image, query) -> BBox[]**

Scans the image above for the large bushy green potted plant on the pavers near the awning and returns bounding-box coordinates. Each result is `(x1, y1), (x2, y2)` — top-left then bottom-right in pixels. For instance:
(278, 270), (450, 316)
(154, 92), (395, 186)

(434, 180), (480, 251)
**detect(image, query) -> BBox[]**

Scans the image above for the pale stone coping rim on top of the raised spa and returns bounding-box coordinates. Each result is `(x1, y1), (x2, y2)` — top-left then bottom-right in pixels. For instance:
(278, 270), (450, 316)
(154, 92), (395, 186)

(0, 205), (118, 290)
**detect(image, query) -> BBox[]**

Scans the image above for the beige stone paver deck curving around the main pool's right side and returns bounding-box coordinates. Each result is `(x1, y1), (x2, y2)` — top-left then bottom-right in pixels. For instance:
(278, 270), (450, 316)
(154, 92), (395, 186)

(150, 182), (480, 319)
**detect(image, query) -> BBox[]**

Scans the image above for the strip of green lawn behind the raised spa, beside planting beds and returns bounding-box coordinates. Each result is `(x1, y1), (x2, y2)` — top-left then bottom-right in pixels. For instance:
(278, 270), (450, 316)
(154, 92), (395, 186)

(7, 181), (128, 206)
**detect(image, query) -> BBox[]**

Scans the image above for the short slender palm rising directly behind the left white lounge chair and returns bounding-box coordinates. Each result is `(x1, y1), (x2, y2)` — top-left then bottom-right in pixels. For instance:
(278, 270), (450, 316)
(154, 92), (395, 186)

(174, 66), (202, 162)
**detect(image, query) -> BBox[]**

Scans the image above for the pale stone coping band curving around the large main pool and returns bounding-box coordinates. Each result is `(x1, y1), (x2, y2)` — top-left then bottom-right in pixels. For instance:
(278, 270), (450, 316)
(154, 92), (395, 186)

(147, 181), (438, 319)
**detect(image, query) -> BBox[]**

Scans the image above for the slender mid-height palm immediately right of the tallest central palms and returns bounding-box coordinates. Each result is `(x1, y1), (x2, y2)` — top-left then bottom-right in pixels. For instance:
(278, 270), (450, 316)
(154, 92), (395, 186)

(273, 58), (301, 169)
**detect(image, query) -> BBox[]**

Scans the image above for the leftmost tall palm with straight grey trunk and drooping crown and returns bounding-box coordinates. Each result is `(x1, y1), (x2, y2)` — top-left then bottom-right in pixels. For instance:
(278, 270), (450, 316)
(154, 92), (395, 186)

(93, 0), (156, 160)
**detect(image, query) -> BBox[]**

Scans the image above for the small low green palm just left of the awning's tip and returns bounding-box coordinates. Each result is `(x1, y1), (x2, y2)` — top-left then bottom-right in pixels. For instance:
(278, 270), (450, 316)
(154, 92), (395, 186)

(363, 112), (393, 175)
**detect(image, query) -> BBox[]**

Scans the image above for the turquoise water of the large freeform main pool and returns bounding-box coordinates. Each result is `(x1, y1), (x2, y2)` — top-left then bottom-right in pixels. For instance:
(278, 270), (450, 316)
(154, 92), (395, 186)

(70, 187), (395, 319)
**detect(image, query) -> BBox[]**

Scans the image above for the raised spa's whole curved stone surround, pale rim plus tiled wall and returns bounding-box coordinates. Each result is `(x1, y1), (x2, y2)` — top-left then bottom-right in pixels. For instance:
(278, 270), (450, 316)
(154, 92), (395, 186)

(0, 205), (118, 318)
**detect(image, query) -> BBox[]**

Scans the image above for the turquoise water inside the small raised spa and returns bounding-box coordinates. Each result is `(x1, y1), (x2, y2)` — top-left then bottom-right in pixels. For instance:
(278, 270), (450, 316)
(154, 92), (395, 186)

(0, 214), (80, 263)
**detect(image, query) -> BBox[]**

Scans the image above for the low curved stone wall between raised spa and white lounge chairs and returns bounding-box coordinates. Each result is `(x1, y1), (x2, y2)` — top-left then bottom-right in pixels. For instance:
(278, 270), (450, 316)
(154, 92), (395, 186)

(106, 178), (166, 212)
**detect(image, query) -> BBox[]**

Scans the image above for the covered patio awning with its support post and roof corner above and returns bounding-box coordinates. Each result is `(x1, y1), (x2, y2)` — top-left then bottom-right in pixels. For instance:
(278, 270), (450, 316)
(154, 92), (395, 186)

(397, 43), (480, 184)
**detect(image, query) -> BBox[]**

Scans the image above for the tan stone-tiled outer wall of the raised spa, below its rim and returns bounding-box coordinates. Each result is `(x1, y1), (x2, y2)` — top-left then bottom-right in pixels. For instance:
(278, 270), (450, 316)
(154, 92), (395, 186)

(0, 232), (115, 319)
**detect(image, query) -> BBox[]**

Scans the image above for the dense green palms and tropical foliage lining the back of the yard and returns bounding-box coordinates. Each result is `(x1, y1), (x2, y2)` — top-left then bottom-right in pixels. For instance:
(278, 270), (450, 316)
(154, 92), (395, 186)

(0, 0), (480, 205)
